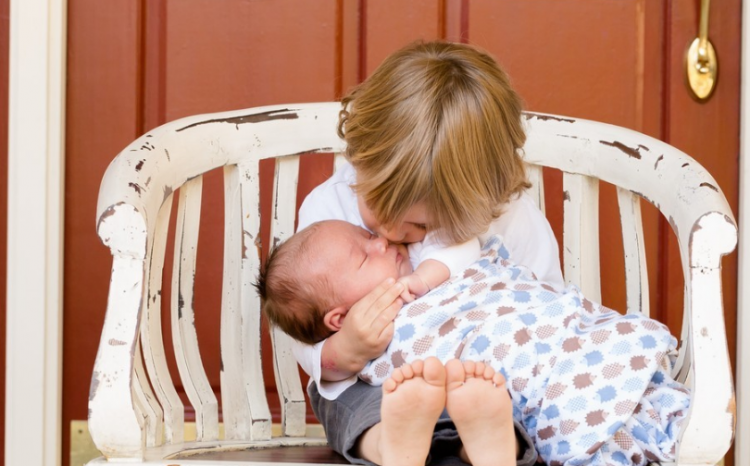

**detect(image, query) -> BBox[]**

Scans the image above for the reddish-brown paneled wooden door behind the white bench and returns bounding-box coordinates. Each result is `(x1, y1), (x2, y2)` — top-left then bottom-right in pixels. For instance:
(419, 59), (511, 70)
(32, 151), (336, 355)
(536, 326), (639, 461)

(63, 0), (740, 461)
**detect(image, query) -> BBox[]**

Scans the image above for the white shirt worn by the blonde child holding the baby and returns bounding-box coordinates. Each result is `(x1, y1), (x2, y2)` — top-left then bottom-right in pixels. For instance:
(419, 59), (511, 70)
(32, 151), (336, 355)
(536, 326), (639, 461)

(292, 163), (565, 400)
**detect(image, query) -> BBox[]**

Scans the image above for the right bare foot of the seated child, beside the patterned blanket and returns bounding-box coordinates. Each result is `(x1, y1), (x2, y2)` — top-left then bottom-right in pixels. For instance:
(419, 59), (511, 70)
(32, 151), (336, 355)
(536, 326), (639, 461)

(445, 359), (516, 466)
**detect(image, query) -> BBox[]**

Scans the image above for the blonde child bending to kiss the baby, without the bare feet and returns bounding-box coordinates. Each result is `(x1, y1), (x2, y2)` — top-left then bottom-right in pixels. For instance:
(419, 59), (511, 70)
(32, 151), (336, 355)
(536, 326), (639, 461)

(293, 42), (563, 466)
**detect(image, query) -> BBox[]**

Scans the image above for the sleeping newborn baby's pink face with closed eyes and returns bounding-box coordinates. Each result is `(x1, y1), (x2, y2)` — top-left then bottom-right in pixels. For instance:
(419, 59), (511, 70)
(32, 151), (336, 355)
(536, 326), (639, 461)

(310, 221), (412, 308)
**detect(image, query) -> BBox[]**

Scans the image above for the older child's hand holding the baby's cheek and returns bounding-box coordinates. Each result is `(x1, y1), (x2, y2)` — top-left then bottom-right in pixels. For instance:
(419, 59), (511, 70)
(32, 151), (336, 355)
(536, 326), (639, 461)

(321, 279), (404, 382)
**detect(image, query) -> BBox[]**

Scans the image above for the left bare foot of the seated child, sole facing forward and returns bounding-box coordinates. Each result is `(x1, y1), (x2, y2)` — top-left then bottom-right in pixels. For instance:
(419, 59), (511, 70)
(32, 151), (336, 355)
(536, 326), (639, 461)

(379, 357), (445, 466)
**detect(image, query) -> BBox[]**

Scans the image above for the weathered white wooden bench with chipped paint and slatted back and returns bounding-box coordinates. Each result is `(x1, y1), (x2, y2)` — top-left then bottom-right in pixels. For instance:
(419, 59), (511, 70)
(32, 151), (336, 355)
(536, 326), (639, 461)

(89, 103), (737, 465)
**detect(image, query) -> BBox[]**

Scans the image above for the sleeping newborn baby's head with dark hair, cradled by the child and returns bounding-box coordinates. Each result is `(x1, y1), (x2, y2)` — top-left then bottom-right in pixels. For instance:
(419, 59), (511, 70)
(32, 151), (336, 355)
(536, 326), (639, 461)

(256, 220), (412, 344)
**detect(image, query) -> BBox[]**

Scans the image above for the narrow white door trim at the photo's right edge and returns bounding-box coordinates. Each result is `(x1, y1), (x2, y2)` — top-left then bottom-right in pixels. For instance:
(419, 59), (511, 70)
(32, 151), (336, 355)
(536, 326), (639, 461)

(734, 4), (750, 465)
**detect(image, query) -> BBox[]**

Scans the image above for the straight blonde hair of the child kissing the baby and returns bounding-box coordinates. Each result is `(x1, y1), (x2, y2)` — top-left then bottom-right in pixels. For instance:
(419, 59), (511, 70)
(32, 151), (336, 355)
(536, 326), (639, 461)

(338, 42), (530, 243)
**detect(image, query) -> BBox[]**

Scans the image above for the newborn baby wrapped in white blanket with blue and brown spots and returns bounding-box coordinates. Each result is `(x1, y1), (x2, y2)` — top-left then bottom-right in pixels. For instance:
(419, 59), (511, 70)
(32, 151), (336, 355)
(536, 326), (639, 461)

(258, 219), (689, 465)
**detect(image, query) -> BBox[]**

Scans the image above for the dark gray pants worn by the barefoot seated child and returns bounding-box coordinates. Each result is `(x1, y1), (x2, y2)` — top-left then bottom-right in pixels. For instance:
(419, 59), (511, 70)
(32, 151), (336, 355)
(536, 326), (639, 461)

(307, 380), (537, 466)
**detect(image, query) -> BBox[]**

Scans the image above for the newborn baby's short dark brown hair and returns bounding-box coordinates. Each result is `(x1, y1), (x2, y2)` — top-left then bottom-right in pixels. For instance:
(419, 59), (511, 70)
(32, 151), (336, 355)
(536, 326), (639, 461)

(255, 224), (334, 345)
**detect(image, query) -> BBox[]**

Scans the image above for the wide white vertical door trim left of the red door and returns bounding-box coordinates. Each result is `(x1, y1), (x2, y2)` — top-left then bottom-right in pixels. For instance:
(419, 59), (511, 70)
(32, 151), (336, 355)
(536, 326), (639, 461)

(5, 0), (67, 466)
